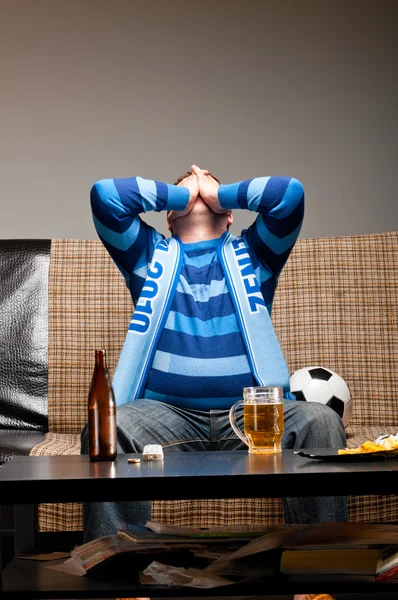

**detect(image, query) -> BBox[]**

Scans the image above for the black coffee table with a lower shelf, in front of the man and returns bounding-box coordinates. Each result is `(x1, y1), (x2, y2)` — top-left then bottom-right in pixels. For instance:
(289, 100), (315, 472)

(0, 450), (398, 600)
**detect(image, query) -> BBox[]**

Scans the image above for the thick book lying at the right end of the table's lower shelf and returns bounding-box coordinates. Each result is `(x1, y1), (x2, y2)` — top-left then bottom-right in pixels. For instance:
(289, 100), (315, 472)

(280, 545), (398, 581)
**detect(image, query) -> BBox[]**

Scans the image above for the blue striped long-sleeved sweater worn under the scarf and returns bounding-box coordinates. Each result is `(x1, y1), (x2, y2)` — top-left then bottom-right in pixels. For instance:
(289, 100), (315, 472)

(91, 177), (304, 410)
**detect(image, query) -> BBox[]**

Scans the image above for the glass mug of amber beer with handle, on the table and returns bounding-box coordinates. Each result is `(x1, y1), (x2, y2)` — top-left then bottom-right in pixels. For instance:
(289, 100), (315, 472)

(229, 386), (284, 454)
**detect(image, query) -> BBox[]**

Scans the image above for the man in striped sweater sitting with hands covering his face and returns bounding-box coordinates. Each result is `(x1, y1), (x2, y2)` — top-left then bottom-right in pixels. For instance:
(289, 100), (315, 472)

(82, 165), (347, 541)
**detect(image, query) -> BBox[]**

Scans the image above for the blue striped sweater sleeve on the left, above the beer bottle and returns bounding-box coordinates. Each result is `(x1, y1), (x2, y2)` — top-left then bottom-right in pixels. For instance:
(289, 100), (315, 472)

(90, 177), (189, 302)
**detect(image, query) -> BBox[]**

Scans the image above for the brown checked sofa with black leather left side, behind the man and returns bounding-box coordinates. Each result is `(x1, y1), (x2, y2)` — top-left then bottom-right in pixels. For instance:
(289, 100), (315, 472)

(0, 232), (398, 531)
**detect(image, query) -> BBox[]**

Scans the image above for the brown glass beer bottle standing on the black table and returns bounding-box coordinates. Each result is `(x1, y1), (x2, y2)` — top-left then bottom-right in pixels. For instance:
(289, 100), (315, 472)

(88, 350), (117, 460)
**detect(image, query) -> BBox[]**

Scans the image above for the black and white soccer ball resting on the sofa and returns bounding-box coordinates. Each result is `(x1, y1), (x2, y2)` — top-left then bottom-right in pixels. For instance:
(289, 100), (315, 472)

(290, 367), (352, 427)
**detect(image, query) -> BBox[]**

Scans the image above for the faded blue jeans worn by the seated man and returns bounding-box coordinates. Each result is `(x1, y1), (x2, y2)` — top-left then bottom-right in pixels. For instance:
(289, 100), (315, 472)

(81, 400), (348, 542)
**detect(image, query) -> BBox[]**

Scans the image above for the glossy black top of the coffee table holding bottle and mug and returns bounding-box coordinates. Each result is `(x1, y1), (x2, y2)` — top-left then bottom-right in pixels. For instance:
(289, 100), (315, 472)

(0, 450), (398, 504)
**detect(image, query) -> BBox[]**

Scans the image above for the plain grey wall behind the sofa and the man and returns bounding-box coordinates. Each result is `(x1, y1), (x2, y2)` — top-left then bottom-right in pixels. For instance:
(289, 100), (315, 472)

(0, 0), (398, 239)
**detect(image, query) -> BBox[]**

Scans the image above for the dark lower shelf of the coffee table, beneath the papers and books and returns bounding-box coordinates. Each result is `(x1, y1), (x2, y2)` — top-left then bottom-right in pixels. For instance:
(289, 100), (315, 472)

(2, 558), (398, 600)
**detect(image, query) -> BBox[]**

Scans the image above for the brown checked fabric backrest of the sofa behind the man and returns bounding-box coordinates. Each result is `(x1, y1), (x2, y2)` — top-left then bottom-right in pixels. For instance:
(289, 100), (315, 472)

(48, 232), (398, 433)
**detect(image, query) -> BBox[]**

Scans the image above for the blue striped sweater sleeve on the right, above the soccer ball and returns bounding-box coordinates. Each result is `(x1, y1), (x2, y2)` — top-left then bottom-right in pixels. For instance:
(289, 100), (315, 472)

(218, 177), (304, 279)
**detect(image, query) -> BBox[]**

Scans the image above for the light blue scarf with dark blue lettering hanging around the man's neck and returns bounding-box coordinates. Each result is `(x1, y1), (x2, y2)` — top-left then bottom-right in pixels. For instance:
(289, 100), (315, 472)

(113, 232), (295, 406)
